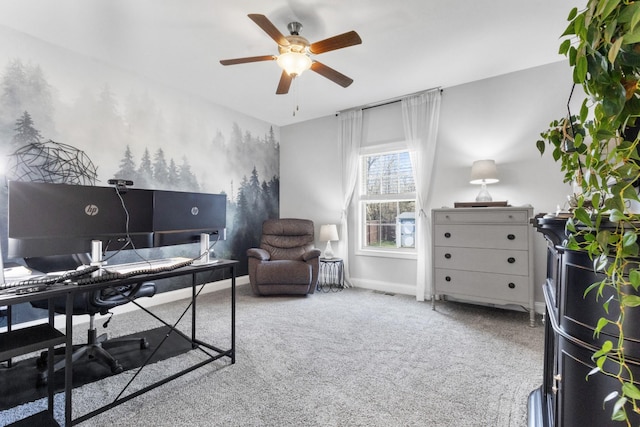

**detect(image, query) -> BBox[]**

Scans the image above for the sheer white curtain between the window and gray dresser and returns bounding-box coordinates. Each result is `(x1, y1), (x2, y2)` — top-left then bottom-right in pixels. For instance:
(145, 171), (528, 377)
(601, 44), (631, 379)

(402, 89), (442, 301)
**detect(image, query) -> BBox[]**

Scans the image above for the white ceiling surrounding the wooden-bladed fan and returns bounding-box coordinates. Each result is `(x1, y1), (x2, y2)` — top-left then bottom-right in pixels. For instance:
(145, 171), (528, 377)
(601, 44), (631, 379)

(0, 0), (581, 126)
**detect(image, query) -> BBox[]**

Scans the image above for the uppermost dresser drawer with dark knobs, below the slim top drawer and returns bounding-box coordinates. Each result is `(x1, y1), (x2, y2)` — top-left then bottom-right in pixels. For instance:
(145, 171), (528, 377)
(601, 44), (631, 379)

(433, 224), (529, 250)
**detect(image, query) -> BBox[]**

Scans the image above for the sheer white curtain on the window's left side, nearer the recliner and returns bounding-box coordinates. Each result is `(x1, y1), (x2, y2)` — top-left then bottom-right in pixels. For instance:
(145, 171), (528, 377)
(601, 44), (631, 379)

(339, 109), (362, 286)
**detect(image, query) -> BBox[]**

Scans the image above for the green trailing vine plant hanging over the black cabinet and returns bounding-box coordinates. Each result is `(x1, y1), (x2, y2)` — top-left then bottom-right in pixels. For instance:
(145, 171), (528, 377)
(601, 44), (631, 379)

(537, 0), (640, 425)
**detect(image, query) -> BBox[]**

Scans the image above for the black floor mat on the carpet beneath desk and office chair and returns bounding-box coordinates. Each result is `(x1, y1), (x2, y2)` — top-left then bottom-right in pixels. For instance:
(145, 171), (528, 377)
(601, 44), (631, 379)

(0, 326), (192, 410)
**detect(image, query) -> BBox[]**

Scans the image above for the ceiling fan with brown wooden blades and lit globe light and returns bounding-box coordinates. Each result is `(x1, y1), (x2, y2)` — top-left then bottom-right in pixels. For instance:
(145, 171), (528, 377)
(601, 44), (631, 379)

(220, 14), (362, 95)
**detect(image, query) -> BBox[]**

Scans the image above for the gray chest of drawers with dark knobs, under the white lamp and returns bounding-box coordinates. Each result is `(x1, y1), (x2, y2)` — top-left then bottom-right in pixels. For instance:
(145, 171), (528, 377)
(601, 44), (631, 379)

(431, 207), (535, 326)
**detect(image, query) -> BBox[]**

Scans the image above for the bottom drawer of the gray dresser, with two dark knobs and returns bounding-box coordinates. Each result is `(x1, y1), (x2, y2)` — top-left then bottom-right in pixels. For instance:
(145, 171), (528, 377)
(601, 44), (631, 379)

(435, 268), (529, 306)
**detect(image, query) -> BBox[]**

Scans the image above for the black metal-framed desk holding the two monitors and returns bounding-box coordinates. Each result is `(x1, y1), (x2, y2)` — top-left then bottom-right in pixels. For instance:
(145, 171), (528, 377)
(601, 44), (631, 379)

(0, 260), (238, 426)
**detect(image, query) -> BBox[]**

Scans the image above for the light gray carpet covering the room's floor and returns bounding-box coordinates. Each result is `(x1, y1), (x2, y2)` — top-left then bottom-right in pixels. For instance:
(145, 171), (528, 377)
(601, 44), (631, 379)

(0, 286), (544, 427)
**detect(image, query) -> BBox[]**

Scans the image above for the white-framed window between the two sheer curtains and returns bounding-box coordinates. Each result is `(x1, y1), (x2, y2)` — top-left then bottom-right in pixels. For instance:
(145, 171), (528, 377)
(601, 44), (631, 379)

(360, 150), (416, 253)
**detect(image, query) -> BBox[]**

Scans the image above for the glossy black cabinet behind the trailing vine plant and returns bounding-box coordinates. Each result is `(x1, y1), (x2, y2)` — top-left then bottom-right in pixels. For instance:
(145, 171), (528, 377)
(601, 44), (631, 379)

(529, 217), (640, 427)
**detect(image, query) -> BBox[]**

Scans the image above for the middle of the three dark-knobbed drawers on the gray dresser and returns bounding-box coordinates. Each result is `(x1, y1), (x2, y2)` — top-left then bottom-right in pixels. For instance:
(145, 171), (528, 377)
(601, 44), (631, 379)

(434, 246), (529, 276)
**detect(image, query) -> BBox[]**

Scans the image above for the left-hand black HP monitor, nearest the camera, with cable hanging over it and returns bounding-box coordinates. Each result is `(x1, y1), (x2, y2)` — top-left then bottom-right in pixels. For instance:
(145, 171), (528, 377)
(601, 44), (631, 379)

(7, 181), (153, 258)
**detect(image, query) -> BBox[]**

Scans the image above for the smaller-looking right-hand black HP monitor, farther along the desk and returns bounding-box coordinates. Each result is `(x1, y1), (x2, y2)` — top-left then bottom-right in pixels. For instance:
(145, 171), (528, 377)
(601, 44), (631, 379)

(153, 190), (227, 246)
